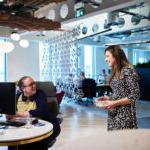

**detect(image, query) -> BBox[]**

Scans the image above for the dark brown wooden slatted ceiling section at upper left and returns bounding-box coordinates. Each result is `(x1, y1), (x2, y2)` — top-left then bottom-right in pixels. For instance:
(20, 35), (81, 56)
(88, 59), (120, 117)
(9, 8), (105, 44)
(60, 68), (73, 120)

(0, 0), (64, 35)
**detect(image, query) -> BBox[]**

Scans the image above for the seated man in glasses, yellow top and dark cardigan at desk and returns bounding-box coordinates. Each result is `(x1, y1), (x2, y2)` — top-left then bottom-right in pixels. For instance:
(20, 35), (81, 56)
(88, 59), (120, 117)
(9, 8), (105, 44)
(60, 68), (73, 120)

(7, 76), (60, 150)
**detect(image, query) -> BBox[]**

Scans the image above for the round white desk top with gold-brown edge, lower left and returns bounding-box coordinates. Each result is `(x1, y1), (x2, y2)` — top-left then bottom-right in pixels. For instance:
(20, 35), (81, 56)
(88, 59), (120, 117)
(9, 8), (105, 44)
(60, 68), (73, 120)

(0, 120), (53, 146)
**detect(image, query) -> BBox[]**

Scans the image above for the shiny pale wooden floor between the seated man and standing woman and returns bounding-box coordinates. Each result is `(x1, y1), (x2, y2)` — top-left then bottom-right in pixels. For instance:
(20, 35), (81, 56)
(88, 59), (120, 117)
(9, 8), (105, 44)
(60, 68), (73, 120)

(49, 96), (107, 150)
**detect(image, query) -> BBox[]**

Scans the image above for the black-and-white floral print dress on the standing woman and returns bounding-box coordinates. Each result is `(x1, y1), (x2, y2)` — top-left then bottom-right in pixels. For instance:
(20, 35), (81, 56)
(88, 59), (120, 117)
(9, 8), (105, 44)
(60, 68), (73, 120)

(107, 67), (140, 130)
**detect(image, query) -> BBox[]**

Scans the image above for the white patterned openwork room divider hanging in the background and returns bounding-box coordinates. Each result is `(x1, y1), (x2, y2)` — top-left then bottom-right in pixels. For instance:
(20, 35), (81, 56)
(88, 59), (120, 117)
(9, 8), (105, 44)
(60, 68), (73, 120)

(40, 27), (81, 83)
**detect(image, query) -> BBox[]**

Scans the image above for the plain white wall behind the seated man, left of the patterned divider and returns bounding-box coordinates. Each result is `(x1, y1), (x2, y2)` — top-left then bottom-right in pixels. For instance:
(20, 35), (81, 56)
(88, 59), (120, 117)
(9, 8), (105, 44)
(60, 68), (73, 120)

(7, 42), (40, 81)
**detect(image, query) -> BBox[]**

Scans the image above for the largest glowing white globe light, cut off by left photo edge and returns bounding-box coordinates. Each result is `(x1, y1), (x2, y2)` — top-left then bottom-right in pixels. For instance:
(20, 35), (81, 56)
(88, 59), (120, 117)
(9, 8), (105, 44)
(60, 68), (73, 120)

(0, 41), (15, 53)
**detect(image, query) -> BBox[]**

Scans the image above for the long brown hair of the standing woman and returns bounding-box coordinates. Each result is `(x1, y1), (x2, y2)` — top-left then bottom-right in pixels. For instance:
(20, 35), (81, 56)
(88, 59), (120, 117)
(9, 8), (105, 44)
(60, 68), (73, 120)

(105, 45), (130, 83)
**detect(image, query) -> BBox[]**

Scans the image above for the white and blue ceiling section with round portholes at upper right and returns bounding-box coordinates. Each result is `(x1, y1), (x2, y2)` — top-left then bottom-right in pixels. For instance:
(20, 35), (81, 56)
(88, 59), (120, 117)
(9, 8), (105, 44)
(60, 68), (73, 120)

(74, 1), (150, 50)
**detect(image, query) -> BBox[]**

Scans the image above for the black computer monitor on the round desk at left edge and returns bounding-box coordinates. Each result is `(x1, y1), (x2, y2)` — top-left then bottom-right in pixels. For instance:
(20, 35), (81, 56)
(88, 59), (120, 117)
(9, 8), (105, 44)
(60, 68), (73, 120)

(0, 82), (16, 115)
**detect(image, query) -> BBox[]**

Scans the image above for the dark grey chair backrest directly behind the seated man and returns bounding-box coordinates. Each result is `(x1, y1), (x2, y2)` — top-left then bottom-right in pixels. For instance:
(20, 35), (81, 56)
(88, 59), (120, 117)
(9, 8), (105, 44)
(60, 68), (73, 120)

(36, 81), (59, 116)
